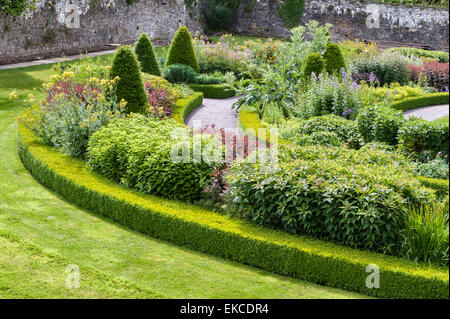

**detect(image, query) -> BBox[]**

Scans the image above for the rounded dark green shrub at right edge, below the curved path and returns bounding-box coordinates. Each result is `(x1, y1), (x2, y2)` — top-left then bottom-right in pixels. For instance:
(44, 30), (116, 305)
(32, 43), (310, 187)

(398, 118), (449, 161)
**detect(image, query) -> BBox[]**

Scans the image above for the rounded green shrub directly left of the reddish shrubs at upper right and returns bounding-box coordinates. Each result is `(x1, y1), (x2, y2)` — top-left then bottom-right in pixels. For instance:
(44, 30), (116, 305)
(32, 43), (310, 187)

(353, 53), (411, 85)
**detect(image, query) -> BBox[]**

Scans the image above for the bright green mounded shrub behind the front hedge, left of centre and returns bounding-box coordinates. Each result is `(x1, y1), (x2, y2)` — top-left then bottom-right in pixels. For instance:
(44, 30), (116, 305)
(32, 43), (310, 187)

(88, 114), (221, 201)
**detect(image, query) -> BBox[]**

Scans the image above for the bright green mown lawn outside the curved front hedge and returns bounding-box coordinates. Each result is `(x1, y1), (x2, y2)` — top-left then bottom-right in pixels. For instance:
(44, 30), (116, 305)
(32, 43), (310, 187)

(0, 60), (365, 298)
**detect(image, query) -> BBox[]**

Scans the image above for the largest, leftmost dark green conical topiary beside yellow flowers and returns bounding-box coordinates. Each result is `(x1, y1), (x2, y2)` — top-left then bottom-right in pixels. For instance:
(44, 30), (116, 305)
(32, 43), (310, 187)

(110, 45), (148, 113)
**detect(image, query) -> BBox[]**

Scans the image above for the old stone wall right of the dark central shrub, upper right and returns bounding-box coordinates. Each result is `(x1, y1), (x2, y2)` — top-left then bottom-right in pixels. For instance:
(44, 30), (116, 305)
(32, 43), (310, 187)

(234, 0), (449, 50)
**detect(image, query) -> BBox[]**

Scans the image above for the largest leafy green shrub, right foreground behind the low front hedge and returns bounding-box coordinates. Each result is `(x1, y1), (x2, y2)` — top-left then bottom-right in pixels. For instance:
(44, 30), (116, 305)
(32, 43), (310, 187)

(228, 146), (435, 252)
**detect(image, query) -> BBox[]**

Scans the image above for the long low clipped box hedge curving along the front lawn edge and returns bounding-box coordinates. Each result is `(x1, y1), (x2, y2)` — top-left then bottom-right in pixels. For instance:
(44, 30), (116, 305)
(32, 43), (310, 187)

(18, 120), (449, 298)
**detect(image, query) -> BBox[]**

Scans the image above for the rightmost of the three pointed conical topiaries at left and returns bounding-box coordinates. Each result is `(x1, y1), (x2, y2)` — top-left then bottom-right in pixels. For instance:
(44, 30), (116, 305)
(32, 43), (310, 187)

(166, 26), (200, 73)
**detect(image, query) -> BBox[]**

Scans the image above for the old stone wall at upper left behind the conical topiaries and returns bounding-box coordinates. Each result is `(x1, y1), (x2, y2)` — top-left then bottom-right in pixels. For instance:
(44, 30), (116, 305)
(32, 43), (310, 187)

(0, 0), (202, 64)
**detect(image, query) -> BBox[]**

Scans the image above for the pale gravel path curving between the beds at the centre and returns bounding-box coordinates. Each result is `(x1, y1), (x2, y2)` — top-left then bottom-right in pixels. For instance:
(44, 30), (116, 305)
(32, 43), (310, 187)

(185, 97), (239, 129)
